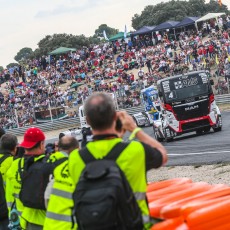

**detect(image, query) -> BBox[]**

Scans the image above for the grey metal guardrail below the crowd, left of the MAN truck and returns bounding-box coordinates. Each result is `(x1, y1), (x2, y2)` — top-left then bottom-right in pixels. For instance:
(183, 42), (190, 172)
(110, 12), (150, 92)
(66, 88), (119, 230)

(7, 106), (144, 136)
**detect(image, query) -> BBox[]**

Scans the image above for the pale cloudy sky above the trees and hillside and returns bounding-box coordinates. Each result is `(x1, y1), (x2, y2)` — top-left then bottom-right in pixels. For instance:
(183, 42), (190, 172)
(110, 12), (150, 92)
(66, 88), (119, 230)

(0, 0), (230, 67)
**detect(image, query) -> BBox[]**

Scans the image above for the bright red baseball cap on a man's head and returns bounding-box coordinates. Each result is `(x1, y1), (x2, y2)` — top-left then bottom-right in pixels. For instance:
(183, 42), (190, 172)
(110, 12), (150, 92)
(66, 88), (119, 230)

(20, 127), (45, 149)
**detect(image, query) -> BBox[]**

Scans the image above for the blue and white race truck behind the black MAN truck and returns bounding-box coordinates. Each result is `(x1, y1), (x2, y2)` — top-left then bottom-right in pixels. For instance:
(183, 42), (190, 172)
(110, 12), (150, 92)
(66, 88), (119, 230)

(133, 86), (161, 126)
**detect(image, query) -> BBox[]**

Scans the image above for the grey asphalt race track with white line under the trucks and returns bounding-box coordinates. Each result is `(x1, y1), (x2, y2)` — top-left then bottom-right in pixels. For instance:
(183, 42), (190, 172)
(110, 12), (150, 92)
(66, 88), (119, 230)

(47, 112), (230, 166)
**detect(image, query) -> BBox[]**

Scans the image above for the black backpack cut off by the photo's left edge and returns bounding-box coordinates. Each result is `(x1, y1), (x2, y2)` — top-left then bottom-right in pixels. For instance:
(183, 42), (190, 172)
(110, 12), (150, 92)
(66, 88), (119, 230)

(0, 154), (10, 220)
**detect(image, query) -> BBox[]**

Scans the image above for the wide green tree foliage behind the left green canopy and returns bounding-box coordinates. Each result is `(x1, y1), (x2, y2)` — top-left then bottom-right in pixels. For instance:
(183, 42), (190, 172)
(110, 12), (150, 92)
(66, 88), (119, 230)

(33, 33), (100, 57)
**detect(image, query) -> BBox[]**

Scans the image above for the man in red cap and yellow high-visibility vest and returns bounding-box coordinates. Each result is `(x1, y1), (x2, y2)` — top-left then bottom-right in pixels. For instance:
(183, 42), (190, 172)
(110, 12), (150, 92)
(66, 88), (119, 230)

(6, 127), (46, 230)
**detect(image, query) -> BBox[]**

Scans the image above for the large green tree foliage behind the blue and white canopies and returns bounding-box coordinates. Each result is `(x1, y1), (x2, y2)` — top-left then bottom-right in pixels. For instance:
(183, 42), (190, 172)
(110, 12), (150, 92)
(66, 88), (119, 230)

(132, 0), (229, 30)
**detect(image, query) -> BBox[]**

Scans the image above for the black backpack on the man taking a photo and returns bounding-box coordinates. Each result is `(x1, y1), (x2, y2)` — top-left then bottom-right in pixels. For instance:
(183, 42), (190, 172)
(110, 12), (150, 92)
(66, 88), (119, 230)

(73, 142), (143, 230)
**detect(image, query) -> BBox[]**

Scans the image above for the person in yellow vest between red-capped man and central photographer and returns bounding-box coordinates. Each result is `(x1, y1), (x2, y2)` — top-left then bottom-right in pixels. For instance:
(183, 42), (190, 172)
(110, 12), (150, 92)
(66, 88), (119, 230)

(43, 136), (79, 230)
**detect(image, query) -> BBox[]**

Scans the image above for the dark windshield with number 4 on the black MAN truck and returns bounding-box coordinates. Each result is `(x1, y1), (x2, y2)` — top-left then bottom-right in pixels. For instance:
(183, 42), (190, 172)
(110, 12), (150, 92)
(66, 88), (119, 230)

(161, 73), (209, 103)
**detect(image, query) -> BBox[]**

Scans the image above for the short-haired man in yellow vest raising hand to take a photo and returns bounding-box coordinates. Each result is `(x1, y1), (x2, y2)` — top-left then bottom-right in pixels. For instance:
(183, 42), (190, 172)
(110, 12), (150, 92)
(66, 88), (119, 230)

(69, 93), (167, 229)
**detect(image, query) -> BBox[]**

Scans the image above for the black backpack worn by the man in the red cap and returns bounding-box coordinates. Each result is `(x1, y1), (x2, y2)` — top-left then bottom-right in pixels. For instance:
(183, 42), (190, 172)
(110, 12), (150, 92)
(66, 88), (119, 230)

(18, 155), (67, 210)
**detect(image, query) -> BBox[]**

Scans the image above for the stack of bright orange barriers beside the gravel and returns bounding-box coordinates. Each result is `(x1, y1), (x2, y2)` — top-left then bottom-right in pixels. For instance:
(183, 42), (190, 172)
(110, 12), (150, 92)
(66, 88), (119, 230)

(147, 178), (230, 230)
